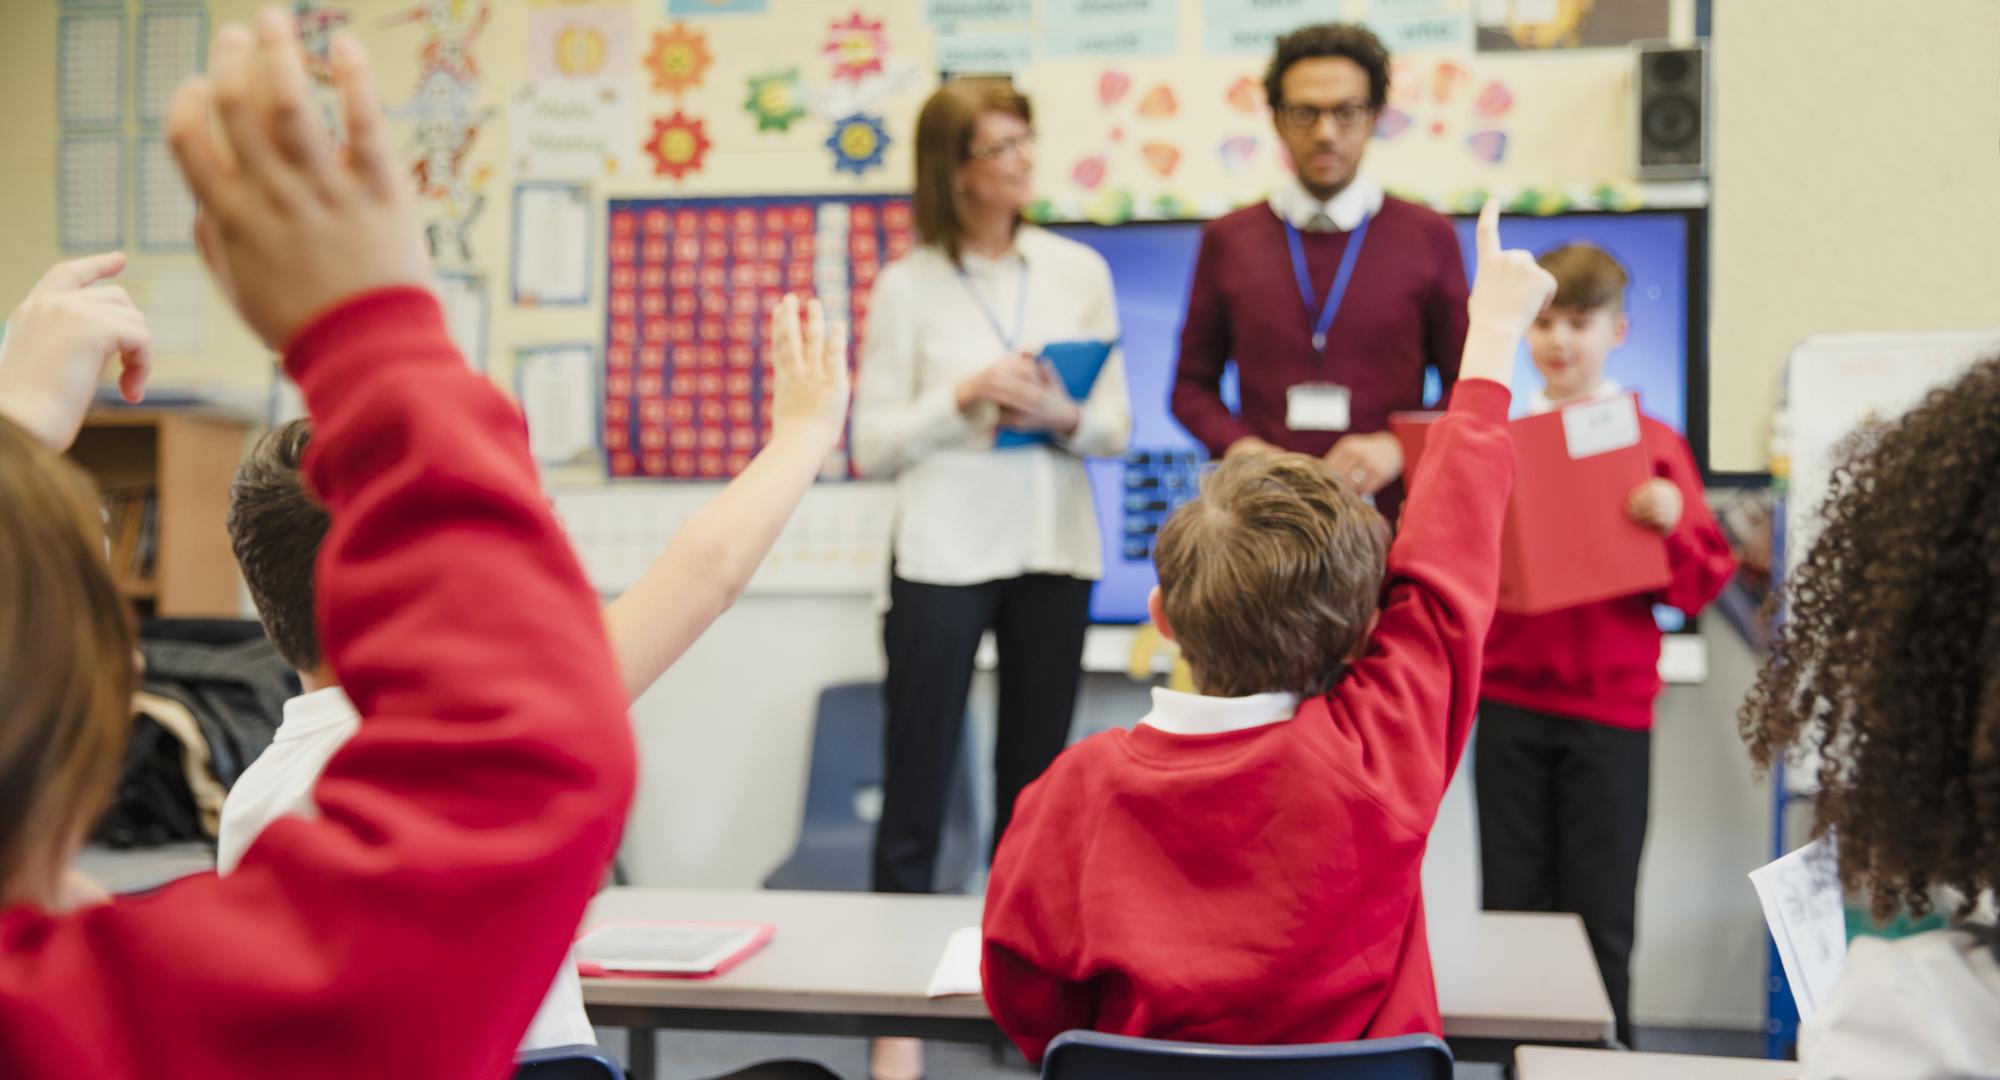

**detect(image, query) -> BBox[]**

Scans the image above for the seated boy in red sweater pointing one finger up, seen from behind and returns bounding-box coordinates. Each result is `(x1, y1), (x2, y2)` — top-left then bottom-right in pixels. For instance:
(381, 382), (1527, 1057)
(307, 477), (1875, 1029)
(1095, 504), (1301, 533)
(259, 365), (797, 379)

(982, 204), (1554, 1060)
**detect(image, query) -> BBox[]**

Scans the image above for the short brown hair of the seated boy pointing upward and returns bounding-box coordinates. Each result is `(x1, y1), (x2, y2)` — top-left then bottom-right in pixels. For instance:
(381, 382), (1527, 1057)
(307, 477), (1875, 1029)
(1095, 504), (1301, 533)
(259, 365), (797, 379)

(1152, 454), (1388, 698)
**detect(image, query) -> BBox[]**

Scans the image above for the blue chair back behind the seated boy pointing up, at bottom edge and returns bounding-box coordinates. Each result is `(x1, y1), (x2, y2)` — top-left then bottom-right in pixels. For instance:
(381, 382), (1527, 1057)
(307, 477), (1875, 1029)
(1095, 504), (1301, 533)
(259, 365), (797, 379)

(1042, 1032), (1452, 1080)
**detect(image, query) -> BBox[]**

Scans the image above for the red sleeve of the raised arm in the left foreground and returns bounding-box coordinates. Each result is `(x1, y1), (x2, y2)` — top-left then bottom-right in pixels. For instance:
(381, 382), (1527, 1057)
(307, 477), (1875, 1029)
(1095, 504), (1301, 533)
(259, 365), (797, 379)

(0, 288), (634, 1080)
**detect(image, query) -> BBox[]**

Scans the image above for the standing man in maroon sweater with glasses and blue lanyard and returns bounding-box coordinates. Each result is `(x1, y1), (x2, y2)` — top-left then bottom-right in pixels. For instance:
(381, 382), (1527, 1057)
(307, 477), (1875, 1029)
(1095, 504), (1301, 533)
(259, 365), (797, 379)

(1172, 24), (1466, 520)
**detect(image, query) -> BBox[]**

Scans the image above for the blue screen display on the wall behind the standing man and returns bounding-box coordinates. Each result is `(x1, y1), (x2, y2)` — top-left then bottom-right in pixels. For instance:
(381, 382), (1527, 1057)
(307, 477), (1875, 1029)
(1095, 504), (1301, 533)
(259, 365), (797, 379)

(1054, 212), (1690, 622)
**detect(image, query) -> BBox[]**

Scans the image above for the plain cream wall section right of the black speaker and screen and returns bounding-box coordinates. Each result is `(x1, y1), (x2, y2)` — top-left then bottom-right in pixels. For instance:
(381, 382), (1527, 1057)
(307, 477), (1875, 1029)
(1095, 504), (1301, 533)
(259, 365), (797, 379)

(1710, 0), (2000, 470)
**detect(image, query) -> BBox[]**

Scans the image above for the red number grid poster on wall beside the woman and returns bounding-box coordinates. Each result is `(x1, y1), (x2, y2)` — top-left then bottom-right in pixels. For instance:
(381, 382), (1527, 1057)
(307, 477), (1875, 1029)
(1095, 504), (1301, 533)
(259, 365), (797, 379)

(602, 196), (914, 480)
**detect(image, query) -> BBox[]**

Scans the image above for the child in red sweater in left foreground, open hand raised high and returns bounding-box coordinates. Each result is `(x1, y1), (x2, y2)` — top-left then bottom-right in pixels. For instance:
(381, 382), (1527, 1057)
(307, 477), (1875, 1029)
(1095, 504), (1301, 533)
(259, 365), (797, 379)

(0, 6), (634, 1080)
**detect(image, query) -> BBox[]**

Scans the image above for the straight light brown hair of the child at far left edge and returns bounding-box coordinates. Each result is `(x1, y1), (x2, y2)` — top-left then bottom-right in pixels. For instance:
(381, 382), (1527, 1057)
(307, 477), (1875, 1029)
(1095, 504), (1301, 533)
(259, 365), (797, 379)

(0, 418), (138, 894)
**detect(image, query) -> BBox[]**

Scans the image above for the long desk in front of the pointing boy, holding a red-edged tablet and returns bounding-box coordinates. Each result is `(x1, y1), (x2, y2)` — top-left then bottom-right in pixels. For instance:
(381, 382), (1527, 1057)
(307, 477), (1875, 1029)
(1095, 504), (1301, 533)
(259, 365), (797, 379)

(584, 888), (1612, 1080)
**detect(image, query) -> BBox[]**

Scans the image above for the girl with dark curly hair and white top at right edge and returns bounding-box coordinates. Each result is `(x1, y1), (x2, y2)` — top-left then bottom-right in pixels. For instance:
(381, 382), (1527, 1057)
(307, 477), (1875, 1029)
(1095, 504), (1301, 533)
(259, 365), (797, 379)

(1740, 358), (2000, 1078)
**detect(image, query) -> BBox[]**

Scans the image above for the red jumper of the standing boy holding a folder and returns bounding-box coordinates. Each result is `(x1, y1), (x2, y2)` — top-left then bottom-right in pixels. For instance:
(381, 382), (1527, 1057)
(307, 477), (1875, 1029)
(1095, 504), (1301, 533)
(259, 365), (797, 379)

(1480, 414), (1736, 732)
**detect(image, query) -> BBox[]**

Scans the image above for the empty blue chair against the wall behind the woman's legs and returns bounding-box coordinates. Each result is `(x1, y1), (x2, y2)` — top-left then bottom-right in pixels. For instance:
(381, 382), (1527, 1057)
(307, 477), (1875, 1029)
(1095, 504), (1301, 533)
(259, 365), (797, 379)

(764, 682), (984, 892)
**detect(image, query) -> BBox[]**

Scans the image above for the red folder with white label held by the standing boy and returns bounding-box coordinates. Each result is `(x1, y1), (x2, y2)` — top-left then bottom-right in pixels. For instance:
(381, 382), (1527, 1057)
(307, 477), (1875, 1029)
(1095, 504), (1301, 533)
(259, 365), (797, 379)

(1388, 394), (1672, 614)
